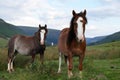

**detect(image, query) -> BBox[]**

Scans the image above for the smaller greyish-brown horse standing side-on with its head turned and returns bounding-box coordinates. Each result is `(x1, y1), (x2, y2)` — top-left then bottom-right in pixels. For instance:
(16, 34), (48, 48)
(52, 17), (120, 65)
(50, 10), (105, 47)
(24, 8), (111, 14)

(7, 24), (47, 72)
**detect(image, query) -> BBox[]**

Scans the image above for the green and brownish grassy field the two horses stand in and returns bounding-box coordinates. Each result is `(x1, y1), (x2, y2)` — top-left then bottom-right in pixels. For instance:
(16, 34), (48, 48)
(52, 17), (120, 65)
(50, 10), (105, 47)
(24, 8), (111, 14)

(0, 41), (120, 80)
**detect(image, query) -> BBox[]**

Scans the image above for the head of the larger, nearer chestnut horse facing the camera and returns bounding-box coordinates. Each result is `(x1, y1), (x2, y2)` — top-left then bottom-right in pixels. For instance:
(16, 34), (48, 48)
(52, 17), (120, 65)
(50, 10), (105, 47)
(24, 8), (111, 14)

(70, 10), (87, 42)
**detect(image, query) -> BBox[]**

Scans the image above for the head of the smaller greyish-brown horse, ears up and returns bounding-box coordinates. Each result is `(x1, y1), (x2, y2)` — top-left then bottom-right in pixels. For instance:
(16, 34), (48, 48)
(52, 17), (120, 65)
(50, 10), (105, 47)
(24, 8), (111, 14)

(35, 24), (48, 45)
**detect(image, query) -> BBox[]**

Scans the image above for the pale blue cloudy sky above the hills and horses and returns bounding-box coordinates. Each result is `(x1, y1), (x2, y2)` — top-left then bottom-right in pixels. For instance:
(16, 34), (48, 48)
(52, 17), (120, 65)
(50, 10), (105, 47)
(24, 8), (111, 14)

(0, 0), (120, 37)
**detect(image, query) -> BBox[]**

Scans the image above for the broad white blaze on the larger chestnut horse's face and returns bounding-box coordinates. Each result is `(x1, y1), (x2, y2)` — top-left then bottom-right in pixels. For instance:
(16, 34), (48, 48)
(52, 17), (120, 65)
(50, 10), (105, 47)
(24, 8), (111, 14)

(77, 17), (83, 41)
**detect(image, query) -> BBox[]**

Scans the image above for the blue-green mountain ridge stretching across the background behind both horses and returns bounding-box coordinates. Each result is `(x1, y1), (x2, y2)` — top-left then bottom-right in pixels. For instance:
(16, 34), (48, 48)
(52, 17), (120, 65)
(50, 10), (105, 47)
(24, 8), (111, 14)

(0, 19), (120, 45)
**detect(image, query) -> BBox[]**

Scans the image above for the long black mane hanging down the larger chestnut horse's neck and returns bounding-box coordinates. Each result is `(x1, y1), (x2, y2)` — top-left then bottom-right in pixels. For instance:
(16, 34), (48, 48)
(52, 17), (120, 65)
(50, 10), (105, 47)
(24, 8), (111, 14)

(67, 17), (76, 46)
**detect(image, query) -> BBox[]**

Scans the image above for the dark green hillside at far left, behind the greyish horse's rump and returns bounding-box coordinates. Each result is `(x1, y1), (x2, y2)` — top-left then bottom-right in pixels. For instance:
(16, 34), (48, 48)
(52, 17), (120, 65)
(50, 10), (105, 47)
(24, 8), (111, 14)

(0, 19), (24, 38)
